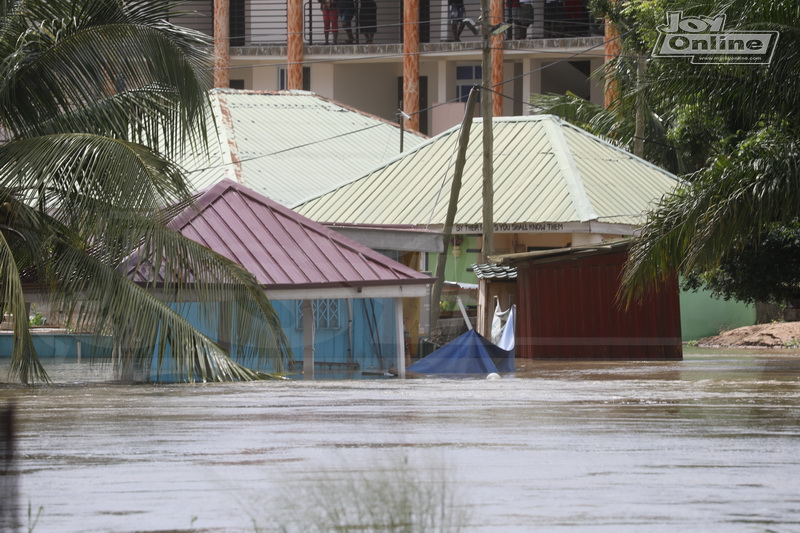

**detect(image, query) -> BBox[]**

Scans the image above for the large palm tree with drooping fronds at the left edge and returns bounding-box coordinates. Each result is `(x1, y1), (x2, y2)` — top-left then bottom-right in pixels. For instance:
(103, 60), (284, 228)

(0, 0), (287, 383)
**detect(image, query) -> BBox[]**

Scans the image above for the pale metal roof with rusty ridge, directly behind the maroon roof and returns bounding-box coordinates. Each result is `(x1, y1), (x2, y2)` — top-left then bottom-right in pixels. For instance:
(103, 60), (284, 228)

(182, 89), (426, 207)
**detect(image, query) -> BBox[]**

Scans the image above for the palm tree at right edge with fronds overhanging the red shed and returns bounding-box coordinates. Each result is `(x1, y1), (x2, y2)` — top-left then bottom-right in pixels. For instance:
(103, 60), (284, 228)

(625, 0), (800, 297)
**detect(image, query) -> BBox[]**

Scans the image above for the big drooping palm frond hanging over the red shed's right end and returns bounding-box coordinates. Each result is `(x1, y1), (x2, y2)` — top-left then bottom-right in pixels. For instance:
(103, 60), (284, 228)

(623, 124), (800, 300)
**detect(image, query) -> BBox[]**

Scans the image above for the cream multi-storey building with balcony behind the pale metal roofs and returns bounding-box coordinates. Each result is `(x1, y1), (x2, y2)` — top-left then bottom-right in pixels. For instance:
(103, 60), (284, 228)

(174, 0), (604, 135)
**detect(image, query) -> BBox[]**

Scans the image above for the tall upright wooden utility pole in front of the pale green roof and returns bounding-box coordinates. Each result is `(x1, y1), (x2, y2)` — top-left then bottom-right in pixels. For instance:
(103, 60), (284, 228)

(480, 0), (494, 263)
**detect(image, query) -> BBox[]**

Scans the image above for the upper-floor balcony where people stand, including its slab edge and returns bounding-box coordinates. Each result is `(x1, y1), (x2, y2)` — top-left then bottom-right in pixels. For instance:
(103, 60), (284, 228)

(178, 0), (602, 51)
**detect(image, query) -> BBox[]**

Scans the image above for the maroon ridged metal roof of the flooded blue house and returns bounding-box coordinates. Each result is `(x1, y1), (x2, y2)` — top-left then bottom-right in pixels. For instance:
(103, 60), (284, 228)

(155, 180), (433, 289)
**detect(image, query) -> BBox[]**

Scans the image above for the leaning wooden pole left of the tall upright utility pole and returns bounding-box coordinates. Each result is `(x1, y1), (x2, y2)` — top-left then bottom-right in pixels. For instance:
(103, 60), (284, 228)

(431, 87), (478, 327)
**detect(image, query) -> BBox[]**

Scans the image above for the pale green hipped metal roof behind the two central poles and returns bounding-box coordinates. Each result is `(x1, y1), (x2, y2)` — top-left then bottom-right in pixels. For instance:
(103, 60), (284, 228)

(297, 115), (678, 227)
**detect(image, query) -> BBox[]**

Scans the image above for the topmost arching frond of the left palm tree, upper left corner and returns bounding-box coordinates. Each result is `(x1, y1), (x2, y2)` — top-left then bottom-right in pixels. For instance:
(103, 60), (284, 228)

(0, 0), (210, 150)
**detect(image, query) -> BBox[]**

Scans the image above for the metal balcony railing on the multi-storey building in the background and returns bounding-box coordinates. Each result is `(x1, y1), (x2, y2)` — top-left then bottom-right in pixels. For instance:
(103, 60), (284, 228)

(173, 0), (602, 47)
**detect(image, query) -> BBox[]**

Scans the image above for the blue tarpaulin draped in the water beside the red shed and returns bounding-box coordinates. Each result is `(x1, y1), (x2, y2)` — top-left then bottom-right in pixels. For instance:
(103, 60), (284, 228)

(406, 329), (514, 374)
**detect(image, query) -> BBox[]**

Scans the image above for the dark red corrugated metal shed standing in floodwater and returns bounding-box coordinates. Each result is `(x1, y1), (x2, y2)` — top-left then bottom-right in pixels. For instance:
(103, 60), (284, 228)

(507, 247), (682, 361)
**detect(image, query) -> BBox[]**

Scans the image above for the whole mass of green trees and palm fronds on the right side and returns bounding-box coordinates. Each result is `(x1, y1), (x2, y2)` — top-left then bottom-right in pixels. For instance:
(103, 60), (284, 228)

(535, 0), (800, 300)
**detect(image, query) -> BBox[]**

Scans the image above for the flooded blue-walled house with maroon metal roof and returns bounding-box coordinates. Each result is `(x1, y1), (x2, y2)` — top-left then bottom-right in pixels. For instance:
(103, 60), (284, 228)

(131, 180), (433, 378)
